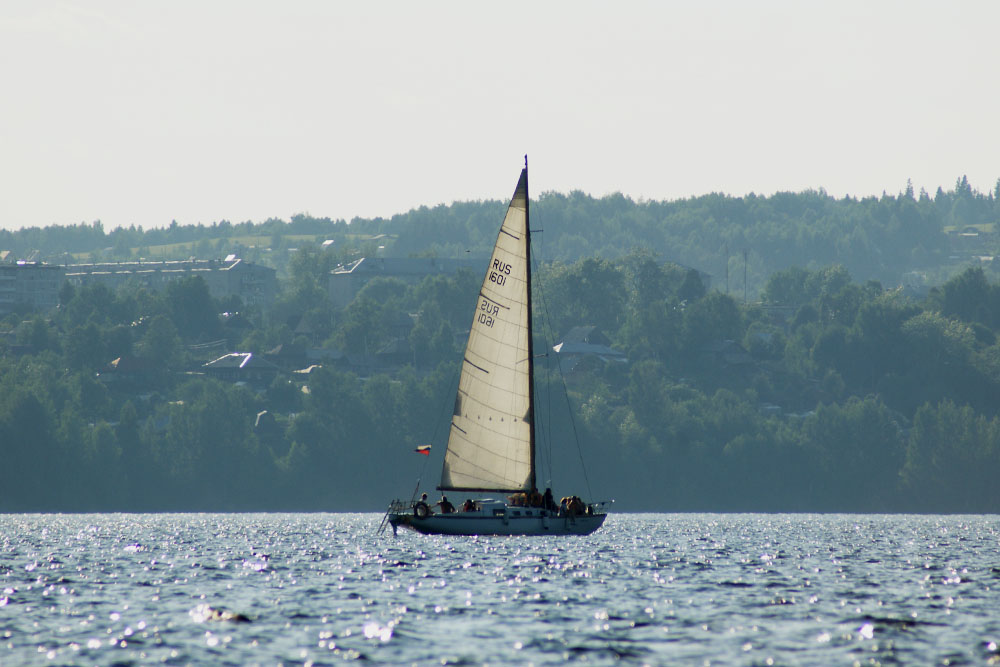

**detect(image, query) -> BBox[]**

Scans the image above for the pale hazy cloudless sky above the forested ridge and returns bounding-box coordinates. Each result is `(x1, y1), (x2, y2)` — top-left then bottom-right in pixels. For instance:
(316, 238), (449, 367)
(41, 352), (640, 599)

(0, 0), (1000, 230)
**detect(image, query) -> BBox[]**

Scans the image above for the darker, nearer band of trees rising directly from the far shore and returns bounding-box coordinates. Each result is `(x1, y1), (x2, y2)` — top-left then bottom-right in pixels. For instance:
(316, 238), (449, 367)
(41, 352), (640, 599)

(0, 248), (1000, 512)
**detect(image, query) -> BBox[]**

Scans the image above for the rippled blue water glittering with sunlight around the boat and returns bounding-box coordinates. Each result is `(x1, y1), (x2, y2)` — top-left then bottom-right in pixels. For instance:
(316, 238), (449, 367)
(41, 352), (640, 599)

(0, 514), (1000, 665)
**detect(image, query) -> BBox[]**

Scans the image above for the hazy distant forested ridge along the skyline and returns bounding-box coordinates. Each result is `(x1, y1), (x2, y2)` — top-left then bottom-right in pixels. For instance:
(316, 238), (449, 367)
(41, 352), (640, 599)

(0, 176), (1000, 298)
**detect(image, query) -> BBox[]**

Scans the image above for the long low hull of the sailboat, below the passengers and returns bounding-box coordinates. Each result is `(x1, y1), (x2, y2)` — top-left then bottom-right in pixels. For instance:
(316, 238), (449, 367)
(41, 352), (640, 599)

(389, 512), (607, 535)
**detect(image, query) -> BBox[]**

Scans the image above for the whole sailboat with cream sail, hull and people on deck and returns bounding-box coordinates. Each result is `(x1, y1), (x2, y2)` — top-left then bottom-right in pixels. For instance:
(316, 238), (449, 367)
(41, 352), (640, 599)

(383, 157), (607, 535)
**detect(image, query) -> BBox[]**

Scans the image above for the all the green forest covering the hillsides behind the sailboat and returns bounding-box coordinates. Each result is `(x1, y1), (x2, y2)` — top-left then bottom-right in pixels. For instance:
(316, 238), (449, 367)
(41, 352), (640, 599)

(0, 179), (1000, 512)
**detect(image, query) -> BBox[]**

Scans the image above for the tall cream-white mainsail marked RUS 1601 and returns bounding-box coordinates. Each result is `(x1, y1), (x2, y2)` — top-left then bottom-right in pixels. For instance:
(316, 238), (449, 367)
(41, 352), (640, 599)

(440, 166), (535, 491)
